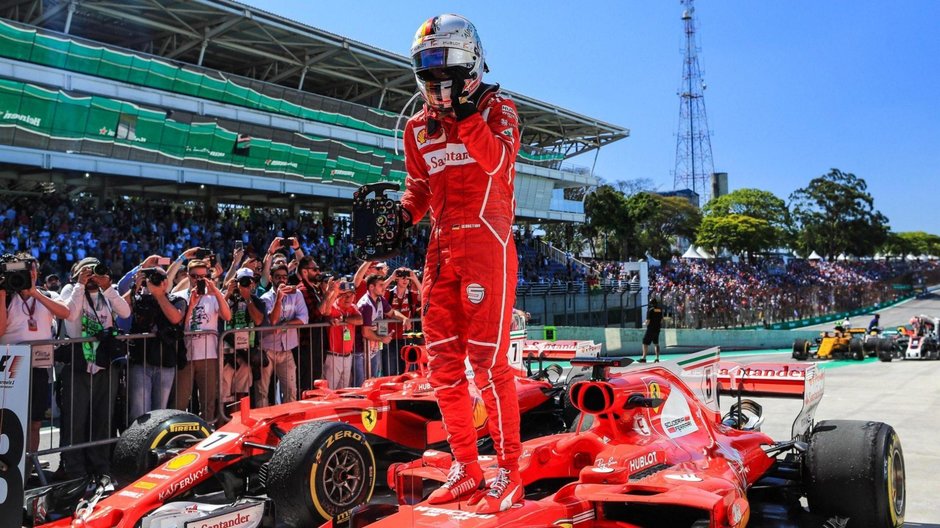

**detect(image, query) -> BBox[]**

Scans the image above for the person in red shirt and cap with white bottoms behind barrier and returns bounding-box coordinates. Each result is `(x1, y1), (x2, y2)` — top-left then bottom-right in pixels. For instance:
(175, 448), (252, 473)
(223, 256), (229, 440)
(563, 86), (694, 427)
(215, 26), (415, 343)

(323, 282), (362, 390)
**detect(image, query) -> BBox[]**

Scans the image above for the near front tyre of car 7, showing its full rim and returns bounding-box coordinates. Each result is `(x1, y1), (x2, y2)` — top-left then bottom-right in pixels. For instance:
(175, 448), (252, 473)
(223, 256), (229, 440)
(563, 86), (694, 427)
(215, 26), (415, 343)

(266, 421), (375, 527)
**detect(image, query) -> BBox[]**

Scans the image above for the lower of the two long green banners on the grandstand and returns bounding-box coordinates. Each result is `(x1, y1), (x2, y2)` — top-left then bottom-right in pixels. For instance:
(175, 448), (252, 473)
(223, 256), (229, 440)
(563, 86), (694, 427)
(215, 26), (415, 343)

(0, 78), (405, 185)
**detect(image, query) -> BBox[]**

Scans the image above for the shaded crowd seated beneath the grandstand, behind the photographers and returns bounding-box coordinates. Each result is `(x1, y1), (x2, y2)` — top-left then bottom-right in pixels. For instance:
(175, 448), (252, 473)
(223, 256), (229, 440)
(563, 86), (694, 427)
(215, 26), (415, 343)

(0, 194), (428, 277)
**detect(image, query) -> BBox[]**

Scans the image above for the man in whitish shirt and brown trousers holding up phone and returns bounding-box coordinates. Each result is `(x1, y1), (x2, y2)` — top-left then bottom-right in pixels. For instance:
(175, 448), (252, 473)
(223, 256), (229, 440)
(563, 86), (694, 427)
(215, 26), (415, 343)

(176, 259), (232, 421)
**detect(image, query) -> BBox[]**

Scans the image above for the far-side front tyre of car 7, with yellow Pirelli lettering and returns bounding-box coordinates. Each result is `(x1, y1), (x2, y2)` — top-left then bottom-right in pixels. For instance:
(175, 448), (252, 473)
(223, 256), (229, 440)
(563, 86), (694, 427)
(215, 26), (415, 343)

(111, 409), (212, 486)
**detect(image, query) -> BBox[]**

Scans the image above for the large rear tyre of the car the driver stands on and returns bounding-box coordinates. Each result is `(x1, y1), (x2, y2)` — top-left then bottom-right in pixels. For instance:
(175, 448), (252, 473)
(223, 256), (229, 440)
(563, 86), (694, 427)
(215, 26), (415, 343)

(804, 420), (907, 528)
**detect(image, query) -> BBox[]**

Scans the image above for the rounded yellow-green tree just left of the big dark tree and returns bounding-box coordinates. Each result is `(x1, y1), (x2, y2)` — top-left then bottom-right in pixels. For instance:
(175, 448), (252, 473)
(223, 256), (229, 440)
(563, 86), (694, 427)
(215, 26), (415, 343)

(695, 189), (789, 258)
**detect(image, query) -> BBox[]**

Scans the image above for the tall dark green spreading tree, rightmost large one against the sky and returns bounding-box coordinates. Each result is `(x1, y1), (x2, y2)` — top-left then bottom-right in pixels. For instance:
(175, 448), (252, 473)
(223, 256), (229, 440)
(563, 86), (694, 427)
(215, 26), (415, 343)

(790, 169), (888, 258)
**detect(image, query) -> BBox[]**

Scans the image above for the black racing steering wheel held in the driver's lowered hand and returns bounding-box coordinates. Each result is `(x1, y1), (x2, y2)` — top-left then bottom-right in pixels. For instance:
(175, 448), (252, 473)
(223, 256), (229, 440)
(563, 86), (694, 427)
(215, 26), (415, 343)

(352, 183), (407, 260)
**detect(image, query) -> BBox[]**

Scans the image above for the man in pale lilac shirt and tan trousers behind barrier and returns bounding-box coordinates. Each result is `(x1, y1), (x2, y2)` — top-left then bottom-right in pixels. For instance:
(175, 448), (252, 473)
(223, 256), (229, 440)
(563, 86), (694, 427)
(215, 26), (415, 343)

(255, 264), (308, 407)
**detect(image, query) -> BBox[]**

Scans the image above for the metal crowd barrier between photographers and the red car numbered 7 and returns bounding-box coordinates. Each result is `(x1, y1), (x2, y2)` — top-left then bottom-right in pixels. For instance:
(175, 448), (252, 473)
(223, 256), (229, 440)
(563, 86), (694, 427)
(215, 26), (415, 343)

(13, 320), (420, 484)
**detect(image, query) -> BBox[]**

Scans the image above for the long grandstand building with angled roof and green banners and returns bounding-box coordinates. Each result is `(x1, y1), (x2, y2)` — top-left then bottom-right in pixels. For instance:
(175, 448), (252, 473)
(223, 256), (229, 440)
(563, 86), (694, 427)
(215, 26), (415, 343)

(0, 0), (629, 222)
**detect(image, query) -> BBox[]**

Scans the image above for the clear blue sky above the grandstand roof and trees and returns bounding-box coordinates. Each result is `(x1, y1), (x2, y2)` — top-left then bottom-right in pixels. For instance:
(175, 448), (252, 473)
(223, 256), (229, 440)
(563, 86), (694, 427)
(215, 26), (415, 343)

(239, 0), (940, 233)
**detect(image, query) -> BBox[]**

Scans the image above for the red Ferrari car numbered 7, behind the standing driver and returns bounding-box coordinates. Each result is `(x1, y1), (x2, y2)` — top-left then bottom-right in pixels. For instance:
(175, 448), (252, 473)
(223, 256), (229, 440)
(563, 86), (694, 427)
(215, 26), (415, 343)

(26, 346), (592, 528)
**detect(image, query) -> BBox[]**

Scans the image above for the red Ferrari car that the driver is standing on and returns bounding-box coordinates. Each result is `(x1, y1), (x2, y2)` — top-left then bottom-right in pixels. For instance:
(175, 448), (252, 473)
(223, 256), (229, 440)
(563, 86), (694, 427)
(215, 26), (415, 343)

(366, 349), (905, 528)
